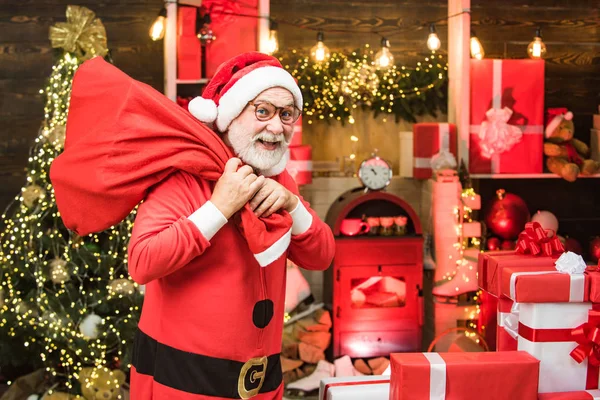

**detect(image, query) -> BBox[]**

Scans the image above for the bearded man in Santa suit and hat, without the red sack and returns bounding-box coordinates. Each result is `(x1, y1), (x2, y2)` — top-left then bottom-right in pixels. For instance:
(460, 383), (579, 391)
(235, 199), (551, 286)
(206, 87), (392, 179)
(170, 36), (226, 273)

(129, 53), (334, 400)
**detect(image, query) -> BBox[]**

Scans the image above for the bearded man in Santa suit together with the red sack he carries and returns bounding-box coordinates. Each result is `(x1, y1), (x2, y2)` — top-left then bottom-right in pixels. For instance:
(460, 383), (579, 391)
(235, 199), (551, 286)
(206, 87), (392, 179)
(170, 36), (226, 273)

(51, 52), (335, 400)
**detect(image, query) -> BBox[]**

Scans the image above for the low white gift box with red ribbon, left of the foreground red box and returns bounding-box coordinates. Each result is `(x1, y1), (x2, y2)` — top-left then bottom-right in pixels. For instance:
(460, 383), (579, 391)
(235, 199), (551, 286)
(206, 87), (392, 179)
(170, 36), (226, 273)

(319, 375), (390, 400)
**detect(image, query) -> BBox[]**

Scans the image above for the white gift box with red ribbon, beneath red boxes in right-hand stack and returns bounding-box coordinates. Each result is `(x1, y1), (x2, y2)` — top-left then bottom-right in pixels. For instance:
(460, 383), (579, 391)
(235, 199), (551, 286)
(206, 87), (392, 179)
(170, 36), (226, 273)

(518, 303), (598, 393)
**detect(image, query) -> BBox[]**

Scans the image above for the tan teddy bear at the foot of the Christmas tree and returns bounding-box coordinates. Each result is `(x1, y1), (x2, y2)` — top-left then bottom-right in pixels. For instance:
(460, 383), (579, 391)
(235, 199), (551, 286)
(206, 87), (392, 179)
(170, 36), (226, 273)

(79, 367), (125, 400)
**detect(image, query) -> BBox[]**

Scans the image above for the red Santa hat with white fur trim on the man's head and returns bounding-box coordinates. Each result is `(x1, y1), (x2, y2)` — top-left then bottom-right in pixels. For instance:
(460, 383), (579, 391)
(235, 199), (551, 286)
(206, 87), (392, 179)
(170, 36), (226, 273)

(188, 52), (302, 132)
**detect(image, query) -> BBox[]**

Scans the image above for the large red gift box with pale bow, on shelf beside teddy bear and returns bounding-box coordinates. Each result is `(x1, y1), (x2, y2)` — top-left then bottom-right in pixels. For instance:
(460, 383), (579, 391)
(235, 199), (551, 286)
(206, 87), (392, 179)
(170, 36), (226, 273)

(469, 59), (544, 174)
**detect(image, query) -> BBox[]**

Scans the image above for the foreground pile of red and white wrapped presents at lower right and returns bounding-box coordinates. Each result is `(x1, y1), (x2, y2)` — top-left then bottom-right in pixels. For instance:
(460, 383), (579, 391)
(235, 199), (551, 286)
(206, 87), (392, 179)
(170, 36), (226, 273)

(320, 223), (600, 400)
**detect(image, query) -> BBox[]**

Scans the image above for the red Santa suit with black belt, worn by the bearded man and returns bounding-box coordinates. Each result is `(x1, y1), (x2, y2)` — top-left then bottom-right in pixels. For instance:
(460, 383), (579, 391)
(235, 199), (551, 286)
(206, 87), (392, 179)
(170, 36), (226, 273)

(129, 171), (334, 400)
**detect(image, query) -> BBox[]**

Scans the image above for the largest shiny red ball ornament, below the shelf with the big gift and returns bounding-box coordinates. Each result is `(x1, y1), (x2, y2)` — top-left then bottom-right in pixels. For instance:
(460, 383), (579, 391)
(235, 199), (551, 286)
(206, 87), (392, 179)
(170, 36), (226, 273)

(485, 189), (530, 239)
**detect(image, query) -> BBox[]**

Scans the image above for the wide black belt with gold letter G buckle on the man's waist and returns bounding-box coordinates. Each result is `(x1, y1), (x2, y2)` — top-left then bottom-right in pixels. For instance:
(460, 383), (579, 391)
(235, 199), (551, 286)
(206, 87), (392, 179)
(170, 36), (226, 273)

(132, 329), (282, 399)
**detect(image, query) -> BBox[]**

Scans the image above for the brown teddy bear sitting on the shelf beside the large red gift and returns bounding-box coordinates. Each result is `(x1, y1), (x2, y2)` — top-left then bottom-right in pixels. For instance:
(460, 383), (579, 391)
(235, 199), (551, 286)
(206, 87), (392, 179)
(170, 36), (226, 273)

(544, 112), (600, 182)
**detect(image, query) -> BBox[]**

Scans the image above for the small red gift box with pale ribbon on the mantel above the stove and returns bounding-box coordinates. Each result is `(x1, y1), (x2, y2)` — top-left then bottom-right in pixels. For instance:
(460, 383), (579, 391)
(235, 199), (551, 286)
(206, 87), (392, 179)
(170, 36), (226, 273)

(413, 123), (457, 179)
